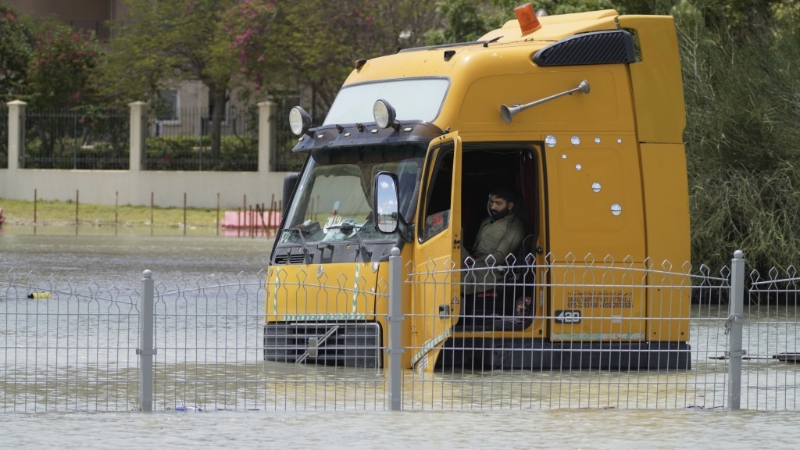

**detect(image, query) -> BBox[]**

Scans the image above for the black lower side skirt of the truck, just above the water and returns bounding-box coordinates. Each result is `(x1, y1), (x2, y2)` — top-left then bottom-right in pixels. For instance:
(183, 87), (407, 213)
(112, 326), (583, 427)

(436, 338), (692, 371)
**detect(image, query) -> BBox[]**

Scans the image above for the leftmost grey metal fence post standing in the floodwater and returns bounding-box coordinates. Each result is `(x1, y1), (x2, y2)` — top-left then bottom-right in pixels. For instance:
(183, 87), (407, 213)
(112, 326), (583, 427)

(136, 270), (155, 412)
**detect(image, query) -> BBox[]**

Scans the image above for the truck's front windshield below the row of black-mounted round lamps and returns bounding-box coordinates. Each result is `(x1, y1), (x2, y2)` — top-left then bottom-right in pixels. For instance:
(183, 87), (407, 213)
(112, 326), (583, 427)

(279, 143), (427, 243)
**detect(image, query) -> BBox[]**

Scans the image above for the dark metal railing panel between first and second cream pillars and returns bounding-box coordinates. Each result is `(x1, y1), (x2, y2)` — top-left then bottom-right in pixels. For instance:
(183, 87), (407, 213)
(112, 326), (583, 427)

(23, 107), (130, 170)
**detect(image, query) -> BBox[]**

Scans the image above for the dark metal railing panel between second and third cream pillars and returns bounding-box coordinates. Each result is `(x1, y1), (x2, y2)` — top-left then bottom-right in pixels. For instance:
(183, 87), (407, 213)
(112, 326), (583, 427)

(143, 107), (258, 171)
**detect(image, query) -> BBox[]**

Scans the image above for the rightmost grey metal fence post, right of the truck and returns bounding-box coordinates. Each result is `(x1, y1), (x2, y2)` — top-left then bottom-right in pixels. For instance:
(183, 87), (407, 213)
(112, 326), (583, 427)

(725, 250), (745, 411)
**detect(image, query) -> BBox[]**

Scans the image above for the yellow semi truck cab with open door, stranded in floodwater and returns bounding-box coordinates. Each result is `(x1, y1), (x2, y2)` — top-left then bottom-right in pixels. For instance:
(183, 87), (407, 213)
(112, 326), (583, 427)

(264, 5), (691, 370)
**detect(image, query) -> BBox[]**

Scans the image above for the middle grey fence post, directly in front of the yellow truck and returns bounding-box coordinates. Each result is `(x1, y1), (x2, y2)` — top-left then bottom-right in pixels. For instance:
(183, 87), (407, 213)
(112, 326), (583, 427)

(388, 247), (403, 411)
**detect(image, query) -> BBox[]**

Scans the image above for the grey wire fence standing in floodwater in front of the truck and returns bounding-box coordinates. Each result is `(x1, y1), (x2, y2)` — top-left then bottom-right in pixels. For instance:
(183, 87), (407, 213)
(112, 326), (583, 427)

(0, 251), (800, 412)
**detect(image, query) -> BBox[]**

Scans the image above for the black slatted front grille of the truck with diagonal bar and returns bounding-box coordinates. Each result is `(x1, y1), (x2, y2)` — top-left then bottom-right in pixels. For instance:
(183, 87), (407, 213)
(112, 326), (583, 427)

(264, 322), (383, 368)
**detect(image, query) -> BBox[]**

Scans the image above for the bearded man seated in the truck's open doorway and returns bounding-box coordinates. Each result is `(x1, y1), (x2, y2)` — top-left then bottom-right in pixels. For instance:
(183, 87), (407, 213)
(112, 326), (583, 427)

(461, 189), (525, 294)
